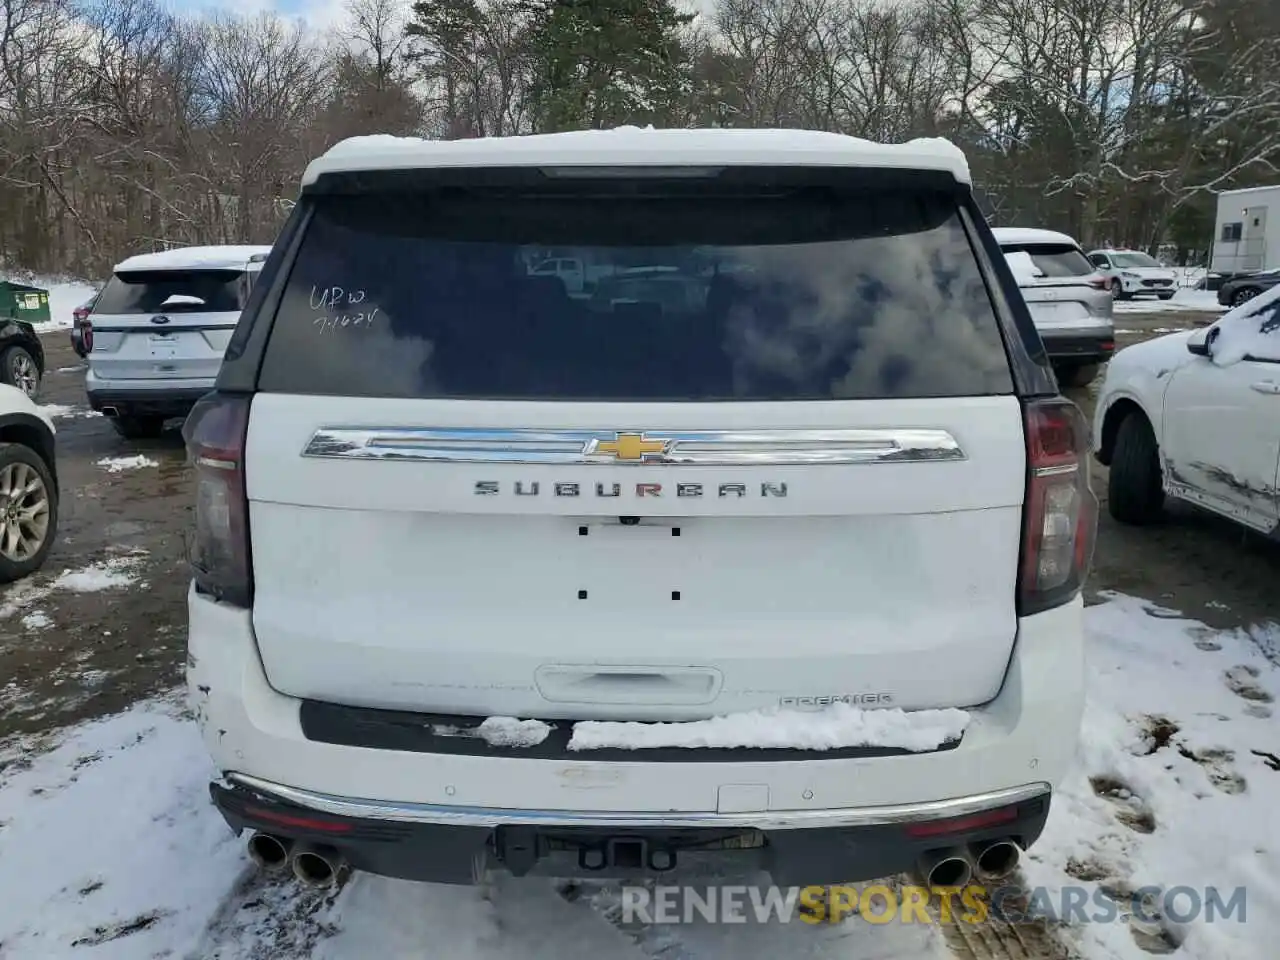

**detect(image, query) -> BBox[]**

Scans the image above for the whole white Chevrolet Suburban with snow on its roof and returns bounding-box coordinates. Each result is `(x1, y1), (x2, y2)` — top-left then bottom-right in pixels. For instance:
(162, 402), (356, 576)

(184, 129), (1096, 883)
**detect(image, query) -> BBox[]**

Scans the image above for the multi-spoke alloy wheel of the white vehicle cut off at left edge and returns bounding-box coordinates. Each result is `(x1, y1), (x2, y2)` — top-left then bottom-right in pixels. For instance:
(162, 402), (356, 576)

(0, 443), (58, 584)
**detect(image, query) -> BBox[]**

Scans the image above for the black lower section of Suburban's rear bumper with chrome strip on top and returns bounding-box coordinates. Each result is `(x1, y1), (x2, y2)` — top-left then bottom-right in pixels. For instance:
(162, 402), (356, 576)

(210, 774), (1050, 886)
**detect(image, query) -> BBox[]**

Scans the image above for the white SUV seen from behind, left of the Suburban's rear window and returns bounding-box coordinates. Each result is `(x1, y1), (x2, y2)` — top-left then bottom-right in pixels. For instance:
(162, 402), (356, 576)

(81, 246), (271, 439)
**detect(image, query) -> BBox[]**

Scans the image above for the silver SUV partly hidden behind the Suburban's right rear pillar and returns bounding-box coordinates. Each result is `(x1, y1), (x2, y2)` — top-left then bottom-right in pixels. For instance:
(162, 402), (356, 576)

(992, 227), (1115, 387)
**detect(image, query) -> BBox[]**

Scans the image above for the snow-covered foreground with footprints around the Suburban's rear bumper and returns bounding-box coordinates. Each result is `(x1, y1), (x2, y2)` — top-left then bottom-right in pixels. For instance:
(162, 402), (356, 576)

(0, 596), (1280, 960)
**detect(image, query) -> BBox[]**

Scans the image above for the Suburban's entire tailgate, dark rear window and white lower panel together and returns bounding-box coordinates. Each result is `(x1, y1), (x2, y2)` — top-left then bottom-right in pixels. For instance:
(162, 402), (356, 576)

(246, 172), (1027, 719)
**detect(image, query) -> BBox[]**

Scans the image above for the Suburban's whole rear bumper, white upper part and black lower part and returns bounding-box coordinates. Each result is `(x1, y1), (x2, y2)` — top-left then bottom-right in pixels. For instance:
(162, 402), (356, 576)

(187, 583), (1083, 883)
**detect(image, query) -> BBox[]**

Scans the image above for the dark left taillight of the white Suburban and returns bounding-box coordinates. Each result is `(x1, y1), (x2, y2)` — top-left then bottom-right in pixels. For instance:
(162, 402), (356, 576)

(182, 392), (253, 607)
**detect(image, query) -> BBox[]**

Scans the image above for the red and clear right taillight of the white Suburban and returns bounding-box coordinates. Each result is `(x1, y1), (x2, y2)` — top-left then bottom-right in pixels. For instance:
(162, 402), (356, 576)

(1018, 398), (1098, 616)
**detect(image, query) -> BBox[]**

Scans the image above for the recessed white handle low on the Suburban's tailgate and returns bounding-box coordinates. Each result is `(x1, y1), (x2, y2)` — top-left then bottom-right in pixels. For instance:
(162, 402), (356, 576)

(534, 663), (724, 707)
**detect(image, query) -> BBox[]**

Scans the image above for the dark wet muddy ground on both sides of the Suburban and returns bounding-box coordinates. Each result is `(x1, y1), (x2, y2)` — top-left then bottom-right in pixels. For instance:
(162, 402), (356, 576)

(0, 320), (1280, 740)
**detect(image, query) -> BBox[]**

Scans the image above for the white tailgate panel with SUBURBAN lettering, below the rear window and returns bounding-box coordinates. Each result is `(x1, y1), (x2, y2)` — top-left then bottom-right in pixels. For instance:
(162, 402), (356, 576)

(247, 394), (1025, 718)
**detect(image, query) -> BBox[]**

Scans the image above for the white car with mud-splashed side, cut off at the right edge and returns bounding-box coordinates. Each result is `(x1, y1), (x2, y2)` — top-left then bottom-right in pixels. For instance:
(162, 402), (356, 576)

(1094, 287), (1280, 536)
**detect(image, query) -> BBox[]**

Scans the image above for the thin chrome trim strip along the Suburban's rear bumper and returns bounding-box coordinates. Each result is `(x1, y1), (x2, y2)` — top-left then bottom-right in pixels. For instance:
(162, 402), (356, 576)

(225, 773), (1050, 829)
